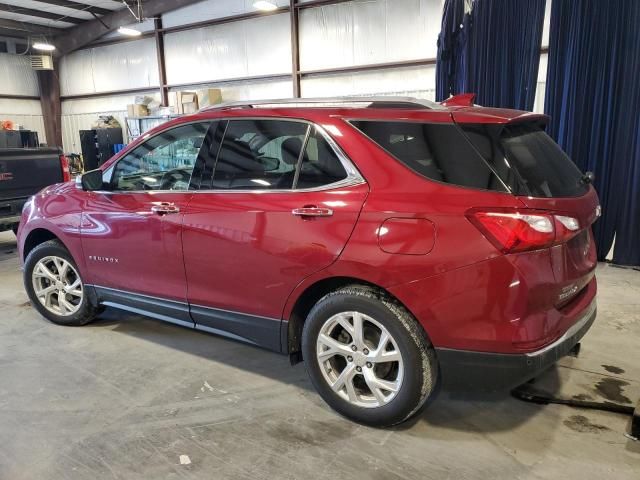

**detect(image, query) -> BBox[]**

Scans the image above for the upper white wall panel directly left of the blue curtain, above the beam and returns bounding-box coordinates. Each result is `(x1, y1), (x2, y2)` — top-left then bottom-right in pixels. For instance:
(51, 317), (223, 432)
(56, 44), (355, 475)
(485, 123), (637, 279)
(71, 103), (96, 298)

(300, 0), (442, 70)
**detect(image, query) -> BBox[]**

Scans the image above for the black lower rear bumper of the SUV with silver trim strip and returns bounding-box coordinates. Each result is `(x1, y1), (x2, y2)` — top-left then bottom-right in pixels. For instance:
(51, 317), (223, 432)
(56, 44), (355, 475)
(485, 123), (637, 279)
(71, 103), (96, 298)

(436, 299), (596, 391)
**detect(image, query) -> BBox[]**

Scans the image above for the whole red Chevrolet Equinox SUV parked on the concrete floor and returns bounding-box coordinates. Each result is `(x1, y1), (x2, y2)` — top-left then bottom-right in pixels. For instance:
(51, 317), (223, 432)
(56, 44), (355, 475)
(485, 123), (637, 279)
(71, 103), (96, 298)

(18, 96), (600, 426)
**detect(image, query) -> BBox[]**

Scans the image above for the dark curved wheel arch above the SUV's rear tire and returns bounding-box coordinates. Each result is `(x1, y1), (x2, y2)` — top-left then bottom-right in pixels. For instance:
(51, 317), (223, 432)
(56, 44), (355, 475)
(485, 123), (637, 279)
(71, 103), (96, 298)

(282, 276), (429, 363)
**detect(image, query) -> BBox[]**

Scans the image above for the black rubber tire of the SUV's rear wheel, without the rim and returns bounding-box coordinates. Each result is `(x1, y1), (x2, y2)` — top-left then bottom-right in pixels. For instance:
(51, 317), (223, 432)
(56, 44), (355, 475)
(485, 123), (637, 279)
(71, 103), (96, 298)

(302, 285), (438, 427)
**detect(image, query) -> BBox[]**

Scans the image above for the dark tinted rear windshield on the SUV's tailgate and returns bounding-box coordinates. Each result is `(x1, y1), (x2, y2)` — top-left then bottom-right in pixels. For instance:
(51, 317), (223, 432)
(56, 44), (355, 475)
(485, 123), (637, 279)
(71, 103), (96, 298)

(460, 123), (588, 198)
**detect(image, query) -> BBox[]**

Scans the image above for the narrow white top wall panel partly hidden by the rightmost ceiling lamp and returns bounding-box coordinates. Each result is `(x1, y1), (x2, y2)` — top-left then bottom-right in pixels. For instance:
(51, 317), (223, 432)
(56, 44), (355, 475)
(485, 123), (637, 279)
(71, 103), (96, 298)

(162, 0), (289, 28)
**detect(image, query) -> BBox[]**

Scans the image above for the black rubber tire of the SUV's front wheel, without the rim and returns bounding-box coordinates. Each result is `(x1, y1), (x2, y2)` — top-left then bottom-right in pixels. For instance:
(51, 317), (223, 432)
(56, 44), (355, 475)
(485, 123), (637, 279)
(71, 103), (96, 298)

(23, 240), (98, 326)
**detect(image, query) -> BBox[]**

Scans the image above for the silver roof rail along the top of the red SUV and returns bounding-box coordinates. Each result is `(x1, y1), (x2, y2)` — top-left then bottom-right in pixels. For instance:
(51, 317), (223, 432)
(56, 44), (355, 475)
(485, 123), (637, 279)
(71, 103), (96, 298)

(200, 96), (443, 112)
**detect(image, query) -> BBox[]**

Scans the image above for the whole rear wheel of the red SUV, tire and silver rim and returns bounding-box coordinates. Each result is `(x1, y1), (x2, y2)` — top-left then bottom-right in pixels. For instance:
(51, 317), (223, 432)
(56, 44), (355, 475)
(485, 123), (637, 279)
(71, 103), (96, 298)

(302, 285), (438, 427)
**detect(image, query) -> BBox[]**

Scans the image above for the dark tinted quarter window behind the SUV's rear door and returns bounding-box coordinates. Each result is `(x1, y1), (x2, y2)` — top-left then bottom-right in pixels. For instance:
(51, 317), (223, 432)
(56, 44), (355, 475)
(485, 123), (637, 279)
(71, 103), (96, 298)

(352, 120), (506, 192)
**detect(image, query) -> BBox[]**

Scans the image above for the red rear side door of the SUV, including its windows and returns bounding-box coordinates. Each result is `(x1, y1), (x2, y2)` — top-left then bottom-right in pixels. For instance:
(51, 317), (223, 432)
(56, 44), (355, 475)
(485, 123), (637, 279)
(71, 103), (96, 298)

(183, 119), (368, 350)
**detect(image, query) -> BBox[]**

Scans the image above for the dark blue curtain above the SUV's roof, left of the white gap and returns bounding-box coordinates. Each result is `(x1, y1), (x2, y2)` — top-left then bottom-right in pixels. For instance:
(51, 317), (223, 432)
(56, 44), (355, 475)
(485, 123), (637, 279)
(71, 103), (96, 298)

(436, 0), (546, 110)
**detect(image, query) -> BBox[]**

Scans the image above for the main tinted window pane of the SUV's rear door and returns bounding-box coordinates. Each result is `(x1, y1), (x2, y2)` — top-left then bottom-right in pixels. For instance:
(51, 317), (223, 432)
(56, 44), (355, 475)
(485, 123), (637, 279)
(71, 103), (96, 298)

(212, 120), (309, 190)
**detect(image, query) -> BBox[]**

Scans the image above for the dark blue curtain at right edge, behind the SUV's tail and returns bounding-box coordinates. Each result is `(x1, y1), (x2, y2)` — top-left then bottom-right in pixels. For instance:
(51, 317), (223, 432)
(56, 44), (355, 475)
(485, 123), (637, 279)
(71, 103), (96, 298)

(545, 0), (640, 265)
